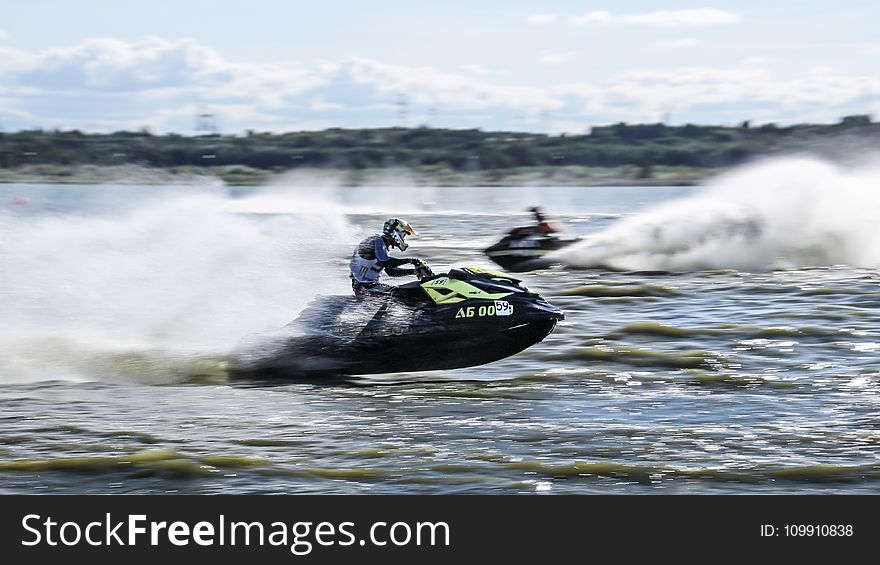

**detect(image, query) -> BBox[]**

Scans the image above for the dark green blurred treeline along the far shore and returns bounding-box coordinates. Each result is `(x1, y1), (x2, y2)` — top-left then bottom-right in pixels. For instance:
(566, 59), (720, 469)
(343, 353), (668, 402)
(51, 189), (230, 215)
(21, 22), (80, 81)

(0, 116), (880, 174)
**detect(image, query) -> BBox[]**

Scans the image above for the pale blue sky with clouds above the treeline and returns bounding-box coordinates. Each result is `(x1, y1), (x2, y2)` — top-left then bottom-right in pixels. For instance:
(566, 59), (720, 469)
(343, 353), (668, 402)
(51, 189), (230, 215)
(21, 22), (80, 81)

(0, 0), (880, 135)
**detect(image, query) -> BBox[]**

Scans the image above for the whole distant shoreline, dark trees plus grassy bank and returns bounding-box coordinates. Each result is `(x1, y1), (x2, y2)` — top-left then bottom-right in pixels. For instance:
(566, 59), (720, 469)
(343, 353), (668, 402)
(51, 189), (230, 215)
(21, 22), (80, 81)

(0, 115), (880, 186)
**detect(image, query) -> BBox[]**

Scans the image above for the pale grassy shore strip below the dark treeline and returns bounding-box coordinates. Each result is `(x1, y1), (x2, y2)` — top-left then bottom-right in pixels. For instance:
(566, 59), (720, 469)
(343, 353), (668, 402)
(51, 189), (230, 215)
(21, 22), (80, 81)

(0, 165), (720, 187)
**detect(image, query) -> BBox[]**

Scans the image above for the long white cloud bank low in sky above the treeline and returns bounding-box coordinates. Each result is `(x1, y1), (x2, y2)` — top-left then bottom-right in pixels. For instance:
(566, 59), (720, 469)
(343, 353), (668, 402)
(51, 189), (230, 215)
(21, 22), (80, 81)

(0, 38), (880, 133)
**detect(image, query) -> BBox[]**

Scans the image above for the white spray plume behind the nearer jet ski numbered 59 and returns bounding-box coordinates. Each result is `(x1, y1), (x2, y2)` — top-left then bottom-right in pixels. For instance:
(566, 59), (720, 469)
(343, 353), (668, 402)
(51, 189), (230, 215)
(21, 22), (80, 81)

(0, 183), (356, 380)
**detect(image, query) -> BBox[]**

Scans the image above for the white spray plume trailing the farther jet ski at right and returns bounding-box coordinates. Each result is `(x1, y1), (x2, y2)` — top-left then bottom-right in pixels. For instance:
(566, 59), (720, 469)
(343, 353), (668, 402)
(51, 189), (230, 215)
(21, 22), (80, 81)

(556, 158), (880, 270)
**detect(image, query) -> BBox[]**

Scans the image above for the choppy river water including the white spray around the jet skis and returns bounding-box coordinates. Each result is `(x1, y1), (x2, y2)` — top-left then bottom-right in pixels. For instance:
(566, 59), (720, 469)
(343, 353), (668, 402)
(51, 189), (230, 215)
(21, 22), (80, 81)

(0, 156), (880, 494)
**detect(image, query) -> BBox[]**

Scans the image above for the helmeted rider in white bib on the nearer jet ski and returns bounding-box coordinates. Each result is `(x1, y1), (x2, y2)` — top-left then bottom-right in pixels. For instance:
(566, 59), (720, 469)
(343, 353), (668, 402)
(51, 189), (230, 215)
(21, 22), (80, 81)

(349, 218), (425, 297)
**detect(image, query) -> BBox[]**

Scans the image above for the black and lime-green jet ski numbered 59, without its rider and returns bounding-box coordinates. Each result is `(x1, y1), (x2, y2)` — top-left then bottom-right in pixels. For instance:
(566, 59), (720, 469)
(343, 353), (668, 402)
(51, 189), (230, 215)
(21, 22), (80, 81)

(231, 265), (564, 378)
